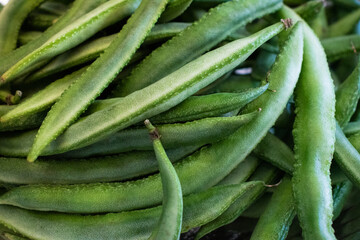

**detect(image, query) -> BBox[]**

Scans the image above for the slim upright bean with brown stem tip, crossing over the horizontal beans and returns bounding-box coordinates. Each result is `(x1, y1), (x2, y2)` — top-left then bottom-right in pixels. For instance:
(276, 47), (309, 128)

(144, 120), (183, 240)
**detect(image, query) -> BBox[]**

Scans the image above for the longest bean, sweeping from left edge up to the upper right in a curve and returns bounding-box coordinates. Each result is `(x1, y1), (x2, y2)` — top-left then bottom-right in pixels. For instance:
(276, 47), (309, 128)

(0, 21), (303, 212)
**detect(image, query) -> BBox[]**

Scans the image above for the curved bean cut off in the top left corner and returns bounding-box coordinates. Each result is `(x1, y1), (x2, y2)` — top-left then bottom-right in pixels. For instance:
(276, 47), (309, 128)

(0, 0), (44, 55)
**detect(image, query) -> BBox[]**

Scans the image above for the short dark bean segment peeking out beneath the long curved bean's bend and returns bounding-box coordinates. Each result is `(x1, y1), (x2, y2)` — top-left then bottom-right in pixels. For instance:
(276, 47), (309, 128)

(217, 155), (260, 186)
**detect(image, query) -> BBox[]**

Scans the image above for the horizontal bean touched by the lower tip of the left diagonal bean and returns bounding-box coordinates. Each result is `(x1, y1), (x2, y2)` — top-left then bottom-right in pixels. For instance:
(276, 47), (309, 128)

(0, 145), (200, 184)
